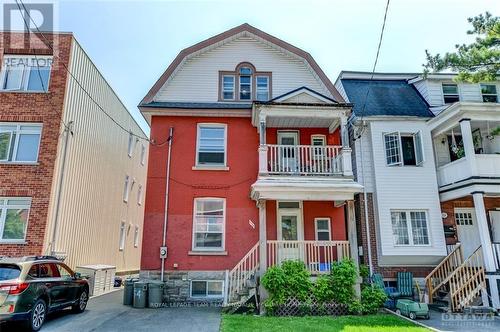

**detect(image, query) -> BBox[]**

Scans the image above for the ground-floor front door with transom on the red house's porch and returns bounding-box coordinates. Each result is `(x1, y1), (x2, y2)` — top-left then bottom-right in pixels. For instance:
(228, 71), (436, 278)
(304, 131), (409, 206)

(278, 202), (304, 262)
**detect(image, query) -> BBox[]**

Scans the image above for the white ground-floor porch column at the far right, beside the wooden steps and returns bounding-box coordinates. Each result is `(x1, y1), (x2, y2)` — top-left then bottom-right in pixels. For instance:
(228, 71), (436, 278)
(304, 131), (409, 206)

(472, 192), (500, 308)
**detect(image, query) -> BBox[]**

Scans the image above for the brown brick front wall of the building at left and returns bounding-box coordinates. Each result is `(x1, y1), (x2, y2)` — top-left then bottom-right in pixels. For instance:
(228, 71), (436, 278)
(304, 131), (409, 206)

(0, 32), (72, 256)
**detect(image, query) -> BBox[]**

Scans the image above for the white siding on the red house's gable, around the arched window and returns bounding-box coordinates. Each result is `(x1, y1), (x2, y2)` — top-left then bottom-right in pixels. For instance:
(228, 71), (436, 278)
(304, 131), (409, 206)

(154, 37), (332, 102)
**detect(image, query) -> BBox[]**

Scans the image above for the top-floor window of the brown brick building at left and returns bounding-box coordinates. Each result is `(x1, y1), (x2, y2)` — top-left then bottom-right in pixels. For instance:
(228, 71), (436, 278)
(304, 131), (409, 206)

(0, 55), (52, 92)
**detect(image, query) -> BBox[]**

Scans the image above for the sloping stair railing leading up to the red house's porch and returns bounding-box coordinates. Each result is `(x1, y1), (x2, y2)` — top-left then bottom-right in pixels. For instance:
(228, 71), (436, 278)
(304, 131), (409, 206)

(228, 242), (259, 302)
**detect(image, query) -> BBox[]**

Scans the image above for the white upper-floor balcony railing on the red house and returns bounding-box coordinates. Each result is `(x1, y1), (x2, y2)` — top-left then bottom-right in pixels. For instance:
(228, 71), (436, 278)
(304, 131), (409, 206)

(259, 144), (352, 176)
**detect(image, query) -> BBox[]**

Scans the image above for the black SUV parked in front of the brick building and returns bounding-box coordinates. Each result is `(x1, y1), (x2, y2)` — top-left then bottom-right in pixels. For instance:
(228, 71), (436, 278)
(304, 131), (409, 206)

(0, 256), (89, 331)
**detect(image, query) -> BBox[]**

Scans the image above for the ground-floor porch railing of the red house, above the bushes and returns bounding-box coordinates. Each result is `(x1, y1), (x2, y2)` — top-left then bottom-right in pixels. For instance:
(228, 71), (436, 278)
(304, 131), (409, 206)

(267, 240), (349, 274)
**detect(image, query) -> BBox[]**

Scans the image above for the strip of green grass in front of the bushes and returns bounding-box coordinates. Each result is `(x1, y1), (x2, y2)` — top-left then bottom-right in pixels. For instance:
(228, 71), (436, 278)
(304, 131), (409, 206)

(221, 314), (428, 332)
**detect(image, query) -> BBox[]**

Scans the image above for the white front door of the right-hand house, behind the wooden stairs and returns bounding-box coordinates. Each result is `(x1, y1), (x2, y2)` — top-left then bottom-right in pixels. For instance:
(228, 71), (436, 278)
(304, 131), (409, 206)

(455, 209), (481, 259)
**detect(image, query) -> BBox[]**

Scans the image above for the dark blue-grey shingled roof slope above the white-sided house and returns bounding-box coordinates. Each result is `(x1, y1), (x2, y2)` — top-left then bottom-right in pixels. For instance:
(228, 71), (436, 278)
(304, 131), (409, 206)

(341, 79), (433, 118)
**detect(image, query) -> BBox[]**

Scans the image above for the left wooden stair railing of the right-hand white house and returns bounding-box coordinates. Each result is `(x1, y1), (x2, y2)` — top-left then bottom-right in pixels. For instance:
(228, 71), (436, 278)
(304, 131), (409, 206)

(425, 243), (464, 303)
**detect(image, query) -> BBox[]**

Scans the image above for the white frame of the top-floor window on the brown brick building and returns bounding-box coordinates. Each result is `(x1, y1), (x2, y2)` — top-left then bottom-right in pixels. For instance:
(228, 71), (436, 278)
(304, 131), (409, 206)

(0, 54), (53, 93)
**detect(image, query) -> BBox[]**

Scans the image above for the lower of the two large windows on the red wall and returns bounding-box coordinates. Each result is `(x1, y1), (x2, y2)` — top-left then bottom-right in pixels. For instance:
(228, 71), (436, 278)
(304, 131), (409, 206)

(193, 198), (226, 250)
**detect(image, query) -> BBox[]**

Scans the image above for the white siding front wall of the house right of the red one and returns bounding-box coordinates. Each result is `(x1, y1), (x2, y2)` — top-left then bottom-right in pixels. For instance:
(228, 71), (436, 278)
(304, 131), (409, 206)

(370, 121), (446, 264)
